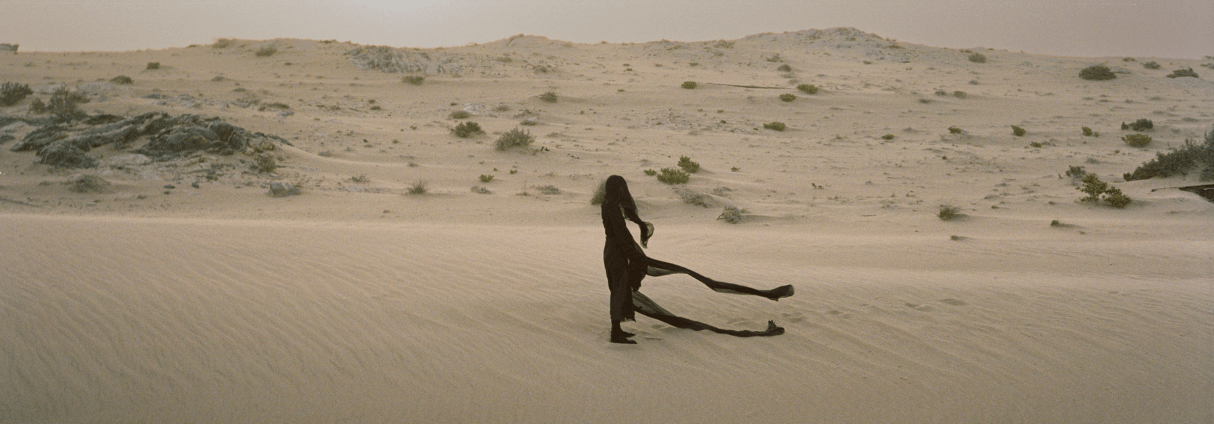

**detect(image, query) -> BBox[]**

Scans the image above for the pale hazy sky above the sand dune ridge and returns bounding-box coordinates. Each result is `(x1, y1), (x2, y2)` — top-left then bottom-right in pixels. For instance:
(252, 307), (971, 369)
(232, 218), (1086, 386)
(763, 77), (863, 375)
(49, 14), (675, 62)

(7, 0), (1214, 58)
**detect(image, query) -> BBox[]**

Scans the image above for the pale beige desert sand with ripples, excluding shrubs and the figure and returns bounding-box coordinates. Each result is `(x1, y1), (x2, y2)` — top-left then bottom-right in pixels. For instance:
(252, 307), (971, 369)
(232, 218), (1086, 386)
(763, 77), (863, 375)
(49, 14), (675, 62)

(0, 28), (1214, 423)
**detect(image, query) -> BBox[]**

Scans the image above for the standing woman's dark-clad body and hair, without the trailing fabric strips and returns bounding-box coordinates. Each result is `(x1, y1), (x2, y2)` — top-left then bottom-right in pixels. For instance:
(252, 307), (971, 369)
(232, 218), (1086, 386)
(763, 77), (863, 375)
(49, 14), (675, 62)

(602, 175), (653, 344)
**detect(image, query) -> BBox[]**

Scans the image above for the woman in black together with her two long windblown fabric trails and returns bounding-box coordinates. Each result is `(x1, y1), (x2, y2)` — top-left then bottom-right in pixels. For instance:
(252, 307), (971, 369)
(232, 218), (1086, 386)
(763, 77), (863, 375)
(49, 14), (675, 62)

(602, 175), (794, 345)
